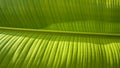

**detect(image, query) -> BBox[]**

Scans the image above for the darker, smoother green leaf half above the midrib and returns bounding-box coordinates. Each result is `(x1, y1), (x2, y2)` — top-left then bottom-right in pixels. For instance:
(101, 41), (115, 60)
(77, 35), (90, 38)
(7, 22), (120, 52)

(0, 0), (120, 33)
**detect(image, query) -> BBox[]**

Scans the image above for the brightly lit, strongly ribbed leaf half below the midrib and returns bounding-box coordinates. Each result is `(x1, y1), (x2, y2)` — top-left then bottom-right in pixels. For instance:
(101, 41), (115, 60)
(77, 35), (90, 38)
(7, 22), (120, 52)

(0, 30), (120, 68)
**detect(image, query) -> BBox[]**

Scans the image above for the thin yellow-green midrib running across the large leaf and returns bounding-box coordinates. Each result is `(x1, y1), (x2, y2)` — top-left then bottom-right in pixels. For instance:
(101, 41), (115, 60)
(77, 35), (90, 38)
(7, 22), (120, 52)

(0, 27), (120, 37)
